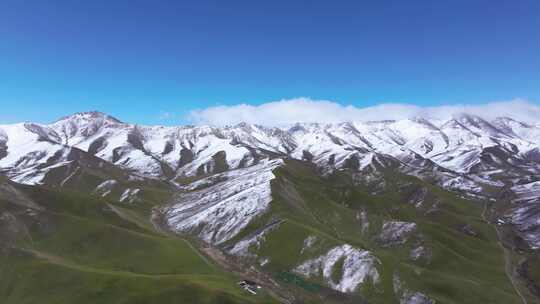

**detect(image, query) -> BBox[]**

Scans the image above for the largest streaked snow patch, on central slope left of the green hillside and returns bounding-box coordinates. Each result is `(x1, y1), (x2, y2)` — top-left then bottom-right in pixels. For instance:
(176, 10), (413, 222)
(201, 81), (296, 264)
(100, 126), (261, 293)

(164, 159), (283, 244)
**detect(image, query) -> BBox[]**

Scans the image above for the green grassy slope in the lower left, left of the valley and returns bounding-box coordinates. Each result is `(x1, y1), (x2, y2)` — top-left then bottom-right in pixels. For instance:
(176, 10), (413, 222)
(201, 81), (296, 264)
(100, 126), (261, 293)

(0, 180), (275, 304)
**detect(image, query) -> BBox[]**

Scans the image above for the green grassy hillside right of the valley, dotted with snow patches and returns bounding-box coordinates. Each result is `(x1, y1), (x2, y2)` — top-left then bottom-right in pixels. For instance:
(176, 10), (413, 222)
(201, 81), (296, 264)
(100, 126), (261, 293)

(227, 161), (521, 304)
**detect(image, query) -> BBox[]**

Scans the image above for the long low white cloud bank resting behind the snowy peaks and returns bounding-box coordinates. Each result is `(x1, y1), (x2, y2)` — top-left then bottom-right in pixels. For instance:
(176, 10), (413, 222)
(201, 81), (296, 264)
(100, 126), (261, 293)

(188, 97), (540, 126)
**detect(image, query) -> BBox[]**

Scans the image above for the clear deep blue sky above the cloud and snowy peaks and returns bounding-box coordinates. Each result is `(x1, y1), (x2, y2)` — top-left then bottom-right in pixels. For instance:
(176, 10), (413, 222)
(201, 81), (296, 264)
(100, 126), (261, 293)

(0, 0), (540, 124)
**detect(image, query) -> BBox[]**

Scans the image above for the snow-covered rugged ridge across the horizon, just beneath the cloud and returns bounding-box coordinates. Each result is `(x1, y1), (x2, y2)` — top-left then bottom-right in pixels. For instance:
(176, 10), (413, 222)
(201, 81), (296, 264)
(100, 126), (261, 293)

(0, 111), (540, 185)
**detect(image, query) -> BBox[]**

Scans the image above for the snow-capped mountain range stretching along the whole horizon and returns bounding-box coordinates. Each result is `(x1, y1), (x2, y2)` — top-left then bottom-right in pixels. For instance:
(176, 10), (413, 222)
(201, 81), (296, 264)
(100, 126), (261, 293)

(0, 112), (540, 191)
